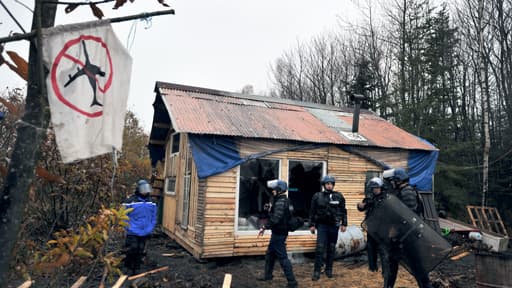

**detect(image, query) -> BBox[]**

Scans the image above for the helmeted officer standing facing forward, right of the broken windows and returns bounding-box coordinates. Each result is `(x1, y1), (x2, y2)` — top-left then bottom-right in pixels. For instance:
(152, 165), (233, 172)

(309, 175), (347, 281)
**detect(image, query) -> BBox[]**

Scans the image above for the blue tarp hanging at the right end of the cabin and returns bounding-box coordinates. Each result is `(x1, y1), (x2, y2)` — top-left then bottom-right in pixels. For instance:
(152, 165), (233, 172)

(407, 137), (439, 191)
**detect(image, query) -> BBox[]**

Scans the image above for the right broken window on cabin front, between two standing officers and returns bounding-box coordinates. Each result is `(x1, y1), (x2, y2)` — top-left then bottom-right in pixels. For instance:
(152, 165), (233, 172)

(288, 160), (324, 230)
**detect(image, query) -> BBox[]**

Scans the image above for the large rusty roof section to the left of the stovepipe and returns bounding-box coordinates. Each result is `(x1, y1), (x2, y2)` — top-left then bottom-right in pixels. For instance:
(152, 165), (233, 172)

(164, 90), (345, 144)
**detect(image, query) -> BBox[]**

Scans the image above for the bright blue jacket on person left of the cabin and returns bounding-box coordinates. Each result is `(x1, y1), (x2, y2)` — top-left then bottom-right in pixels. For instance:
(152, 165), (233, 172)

(123, 194), (157, 236)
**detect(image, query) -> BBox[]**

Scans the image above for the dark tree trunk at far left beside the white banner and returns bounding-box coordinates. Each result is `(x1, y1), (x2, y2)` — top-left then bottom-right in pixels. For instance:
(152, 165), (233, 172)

(0, 0), (57, 287)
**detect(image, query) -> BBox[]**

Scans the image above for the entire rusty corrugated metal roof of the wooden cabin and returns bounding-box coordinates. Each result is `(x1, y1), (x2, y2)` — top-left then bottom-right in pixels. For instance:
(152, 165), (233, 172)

(155, 82), (435, 150)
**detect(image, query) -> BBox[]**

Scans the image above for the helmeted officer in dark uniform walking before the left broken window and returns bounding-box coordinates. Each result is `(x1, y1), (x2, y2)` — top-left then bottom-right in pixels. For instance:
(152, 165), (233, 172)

(260, 180), (297, 288)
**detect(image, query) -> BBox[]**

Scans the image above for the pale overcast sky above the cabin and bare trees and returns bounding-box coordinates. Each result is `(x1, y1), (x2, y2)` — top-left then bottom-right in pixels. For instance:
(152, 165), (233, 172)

(0, 0), (364, 132)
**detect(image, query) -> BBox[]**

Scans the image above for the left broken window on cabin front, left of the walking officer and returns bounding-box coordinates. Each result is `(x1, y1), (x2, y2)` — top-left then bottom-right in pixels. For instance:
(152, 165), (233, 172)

(238, 159), (279, 231)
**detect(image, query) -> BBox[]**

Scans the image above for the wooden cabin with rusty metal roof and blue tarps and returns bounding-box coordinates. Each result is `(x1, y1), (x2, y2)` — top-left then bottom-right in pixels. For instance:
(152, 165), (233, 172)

(148, 82), (438, 259)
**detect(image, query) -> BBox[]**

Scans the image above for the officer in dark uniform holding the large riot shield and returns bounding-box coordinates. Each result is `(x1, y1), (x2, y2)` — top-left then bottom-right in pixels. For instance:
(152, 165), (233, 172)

(381, 168), (432, 288)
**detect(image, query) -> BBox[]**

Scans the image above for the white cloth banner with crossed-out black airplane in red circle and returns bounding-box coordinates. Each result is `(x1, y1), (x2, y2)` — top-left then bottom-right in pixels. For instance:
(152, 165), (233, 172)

(43, 21), (132, 163)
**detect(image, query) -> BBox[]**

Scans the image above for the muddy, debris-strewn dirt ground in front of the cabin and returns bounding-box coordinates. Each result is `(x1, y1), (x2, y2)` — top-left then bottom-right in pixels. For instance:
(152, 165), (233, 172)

(115, 234), (476, 288)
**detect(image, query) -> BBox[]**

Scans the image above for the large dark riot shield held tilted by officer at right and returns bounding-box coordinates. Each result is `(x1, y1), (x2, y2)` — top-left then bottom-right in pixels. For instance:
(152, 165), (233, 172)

(363, 194), (452, 274)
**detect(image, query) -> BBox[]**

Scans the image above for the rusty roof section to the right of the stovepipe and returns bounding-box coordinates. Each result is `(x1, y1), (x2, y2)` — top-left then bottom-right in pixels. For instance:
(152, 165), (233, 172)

(340, 114), (436, 150)
